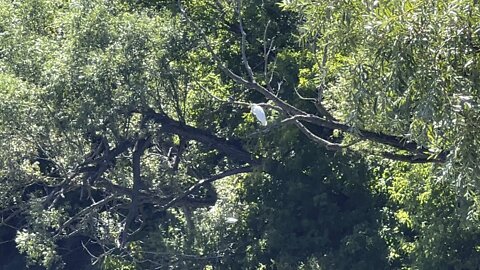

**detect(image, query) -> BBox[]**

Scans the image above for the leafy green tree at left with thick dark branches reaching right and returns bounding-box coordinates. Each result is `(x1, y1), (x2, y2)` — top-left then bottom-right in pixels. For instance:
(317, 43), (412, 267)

(0, 1), (256, 267)
